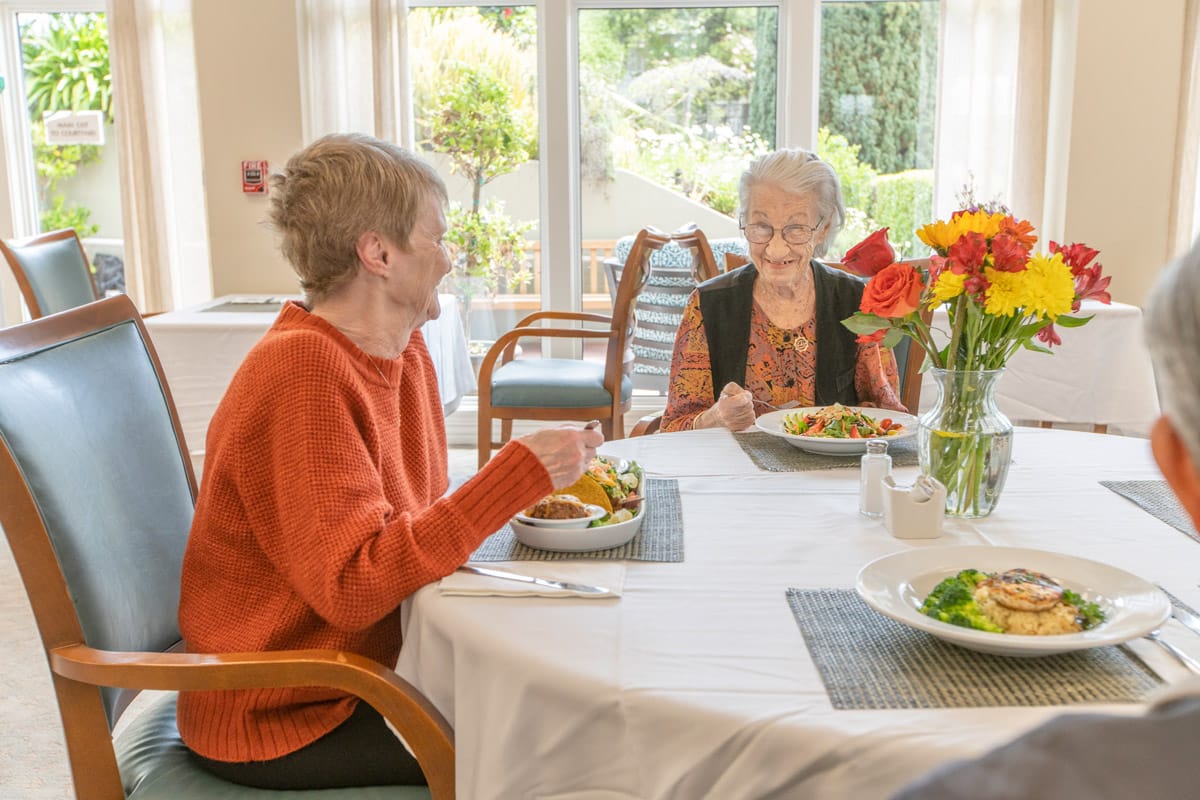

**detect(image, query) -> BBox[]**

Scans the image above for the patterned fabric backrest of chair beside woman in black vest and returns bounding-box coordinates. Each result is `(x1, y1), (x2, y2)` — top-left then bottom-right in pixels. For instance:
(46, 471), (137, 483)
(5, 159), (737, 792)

(605, 224), (745, 395)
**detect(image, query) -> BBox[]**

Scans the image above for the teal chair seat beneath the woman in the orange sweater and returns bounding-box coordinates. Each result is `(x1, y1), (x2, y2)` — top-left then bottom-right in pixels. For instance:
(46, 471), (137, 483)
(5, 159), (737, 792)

(115, 694), (431, 800)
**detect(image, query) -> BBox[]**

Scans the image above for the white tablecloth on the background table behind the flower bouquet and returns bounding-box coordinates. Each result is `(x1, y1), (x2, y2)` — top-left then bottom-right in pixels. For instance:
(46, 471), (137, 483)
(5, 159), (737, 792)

(920, 300), (1158, 434)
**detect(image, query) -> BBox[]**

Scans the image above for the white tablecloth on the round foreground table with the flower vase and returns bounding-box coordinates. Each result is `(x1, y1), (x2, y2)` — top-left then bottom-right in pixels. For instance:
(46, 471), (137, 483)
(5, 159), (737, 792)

(398, 428), (1200, 800)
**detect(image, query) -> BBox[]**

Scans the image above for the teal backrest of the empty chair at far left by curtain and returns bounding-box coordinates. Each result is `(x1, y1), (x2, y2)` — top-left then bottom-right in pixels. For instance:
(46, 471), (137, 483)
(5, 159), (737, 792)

(0, 228), (100, 319)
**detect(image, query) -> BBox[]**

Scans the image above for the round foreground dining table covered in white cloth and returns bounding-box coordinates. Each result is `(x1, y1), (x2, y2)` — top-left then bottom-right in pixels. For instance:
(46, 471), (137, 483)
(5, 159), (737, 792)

(397, 427), (1200, 800)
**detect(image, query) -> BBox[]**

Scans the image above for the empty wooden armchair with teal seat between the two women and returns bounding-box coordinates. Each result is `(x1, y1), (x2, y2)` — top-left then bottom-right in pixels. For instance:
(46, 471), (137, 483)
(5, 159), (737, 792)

(478, 228), (670, 467)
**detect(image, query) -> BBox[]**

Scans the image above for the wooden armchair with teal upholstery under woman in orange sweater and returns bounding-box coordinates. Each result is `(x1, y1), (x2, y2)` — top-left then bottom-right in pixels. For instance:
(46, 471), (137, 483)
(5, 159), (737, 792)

(0, 295), (455, 800)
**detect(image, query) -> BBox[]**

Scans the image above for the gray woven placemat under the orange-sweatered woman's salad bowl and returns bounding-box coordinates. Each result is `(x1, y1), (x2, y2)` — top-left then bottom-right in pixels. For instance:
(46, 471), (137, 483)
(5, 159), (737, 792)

(468, 477), (683, 561)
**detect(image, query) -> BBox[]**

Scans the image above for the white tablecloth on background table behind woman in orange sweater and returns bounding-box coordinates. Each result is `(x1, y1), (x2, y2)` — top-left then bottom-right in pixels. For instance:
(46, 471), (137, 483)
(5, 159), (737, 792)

(145, 294), (475, 453)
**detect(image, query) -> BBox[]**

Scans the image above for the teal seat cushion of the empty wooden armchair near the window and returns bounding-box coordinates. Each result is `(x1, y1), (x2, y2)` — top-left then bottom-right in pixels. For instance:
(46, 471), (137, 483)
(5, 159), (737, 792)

(492, 359), (634, 408)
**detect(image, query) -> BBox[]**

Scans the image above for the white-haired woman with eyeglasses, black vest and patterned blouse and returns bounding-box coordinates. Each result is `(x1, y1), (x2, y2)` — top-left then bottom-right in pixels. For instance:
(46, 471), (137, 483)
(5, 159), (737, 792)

(661, 149), (905, 431)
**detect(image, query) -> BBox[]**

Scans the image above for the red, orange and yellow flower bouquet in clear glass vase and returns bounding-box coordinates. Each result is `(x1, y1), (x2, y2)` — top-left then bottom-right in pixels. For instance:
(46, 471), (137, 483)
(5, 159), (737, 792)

(842, 210), (1111, 517)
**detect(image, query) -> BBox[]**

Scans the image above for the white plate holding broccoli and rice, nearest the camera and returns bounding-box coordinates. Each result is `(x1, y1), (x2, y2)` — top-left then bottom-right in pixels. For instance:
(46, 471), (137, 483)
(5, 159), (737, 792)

(856, 545), (1171, 656)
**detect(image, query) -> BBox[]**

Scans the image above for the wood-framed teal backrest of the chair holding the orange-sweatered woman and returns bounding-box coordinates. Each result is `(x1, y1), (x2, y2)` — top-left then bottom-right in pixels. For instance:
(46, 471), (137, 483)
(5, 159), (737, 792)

(0, 295), (196, 734)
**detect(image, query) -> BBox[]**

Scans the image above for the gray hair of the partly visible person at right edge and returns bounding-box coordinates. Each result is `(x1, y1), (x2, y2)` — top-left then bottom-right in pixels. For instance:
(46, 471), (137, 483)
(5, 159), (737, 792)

(1146, 232), (1200, 468)
